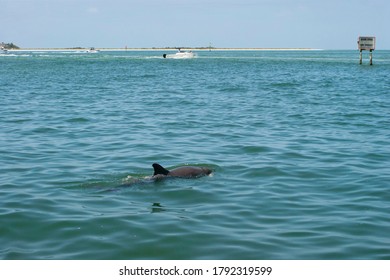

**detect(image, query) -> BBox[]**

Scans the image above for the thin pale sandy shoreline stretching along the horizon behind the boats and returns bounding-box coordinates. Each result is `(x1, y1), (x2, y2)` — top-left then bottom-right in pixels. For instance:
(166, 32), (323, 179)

(12, 47), (322, 52)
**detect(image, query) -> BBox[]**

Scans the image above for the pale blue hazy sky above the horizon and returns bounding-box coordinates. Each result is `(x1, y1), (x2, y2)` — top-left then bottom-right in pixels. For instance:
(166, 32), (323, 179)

(0, 0), (390, 49)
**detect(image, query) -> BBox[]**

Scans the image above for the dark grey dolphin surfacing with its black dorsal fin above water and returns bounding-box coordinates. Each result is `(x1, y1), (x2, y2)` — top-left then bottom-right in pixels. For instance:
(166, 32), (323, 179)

(152, 163), (213, 178)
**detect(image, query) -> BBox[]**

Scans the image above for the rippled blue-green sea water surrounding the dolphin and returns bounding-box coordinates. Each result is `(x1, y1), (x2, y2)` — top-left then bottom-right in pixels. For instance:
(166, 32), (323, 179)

(0, 51), (390, 259)
